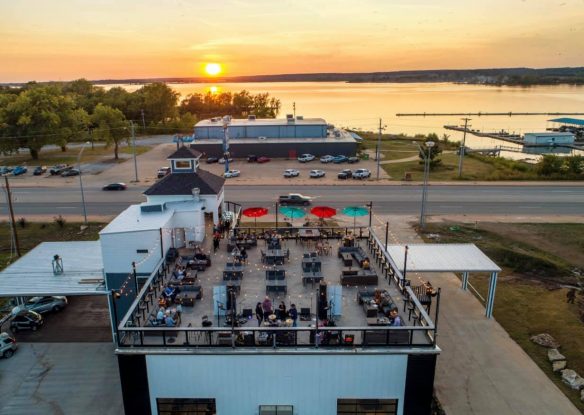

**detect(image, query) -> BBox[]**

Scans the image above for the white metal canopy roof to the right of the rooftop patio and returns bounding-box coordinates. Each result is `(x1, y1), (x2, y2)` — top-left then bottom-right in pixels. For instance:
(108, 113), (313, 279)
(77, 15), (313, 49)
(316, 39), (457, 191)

(387, 244), (501, 272)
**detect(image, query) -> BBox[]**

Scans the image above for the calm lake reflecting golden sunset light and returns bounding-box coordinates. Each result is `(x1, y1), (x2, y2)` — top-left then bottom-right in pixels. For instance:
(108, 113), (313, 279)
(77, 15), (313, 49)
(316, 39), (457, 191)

(110, 82), (584, 159)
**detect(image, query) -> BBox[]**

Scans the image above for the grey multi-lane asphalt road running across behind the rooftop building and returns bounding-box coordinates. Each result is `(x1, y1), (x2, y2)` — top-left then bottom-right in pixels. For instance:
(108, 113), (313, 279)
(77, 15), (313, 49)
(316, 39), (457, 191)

(0, 185), (584, 217)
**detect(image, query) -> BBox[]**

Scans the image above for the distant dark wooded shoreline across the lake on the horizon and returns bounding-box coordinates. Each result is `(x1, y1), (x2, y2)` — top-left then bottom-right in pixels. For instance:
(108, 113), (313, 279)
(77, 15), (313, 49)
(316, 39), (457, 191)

(0, 67), (584, 86)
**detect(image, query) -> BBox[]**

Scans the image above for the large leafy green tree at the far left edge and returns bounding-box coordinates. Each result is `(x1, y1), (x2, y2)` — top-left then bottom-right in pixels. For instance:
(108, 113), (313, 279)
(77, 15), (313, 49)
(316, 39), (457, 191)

(1, 84), (88, 160)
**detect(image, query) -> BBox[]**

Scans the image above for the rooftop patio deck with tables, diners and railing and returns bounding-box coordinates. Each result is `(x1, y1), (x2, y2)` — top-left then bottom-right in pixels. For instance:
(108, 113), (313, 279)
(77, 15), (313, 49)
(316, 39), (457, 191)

(120, 223), (434, 348)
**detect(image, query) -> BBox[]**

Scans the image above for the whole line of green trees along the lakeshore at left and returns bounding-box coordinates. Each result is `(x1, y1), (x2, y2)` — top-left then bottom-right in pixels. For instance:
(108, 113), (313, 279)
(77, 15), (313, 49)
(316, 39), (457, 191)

(0, 79), (280, 160)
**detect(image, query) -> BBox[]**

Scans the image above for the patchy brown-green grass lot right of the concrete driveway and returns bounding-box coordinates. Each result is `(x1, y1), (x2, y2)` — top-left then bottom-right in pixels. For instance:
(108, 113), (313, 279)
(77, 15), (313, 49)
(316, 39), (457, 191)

(420, 223), (584, 412)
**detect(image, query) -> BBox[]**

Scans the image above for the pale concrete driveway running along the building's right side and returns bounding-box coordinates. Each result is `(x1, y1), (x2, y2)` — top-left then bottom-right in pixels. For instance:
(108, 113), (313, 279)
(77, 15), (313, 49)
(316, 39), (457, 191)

(376, 217), (580, 415)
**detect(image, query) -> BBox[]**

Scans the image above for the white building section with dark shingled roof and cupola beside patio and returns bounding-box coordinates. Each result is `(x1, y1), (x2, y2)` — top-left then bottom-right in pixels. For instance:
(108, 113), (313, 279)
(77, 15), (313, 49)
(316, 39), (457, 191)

(100, 147), (225, 323)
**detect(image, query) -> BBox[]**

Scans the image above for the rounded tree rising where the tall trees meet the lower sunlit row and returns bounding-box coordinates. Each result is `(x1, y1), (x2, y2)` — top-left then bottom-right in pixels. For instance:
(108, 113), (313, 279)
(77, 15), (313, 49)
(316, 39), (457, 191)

(135, 82), (179, 124)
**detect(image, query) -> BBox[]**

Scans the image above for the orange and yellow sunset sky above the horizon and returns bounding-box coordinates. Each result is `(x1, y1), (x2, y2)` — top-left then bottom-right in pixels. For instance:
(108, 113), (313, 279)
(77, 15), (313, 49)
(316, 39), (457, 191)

(0, 0), (584, 82)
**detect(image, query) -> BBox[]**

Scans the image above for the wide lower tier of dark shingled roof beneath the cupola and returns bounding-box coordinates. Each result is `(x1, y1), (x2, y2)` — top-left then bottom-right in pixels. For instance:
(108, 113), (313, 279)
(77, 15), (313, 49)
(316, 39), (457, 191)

(144, 169), (225, 196)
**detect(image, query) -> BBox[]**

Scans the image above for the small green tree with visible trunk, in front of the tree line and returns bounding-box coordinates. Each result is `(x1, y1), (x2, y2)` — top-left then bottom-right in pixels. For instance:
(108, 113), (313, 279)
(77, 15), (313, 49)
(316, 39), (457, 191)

(91, 104), (128, 160)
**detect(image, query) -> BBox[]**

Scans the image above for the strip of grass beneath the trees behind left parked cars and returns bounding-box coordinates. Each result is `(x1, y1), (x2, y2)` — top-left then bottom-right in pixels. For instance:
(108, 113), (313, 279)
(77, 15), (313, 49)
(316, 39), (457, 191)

(0, 146), (152, 167)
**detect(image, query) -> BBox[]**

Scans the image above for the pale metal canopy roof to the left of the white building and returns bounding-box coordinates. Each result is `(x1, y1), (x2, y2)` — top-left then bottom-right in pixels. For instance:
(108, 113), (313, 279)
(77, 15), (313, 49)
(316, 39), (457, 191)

(0, 241), (107, 297)
